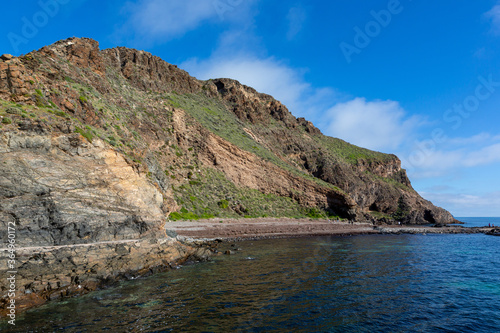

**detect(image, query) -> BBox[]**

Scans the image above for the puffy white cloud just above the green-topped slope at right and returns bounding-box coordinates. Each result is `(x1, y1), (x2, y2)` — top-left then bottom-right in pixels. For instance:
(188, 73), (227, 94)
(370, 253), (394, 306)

(324, 98), (420, 151)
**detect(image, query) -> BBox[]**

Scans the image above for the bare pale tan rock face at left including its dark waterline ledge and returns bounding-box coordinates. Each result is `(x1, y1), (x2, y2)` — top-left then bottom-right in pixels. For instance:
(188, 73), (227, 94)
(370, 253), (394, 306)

(0, 122), (209, 313)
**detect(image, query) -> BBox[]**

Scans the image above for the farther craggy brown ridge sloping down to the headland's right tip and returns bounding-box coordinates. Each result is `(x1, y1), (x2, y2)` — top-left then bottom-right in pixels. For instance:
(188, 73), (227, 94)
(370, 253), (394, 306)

(198, 79), (454, 223)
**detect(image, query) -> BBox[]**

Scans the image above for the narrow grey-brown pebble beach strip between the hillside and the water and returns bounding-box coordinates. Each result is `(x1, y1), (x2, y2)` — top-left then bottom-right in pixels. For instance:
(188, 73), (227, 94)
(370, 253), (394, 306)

(165, 218), (493, 242)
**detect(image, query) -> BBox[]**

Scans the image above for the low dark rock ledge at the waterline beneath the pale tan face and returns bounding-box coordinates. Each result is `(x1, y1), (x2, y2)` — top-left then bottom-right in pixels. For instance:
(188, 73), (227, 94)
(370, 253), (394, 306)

(0, 237), (211, 316)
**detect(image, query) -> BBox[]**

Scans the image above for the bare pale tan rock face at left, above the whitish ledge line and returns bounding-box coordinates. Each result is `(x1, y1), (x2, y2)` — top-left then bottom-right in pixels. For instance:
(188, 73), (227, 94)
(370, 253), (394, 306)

(0, 131), (163, 246)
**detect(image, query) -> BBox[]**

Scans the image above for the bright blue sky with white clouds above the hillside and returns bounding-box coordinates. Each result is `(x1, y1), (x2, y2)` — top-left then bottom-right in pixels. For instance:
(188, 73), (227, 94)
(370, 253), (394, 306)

(0, 0), (500, 216)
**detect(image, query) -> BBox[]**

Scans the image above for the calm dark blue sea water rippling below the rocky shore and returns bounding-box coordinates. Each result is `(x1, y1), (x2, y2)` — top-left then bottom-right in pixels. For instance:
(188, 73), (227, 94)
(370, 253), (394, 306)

(0, 218), (500, 332)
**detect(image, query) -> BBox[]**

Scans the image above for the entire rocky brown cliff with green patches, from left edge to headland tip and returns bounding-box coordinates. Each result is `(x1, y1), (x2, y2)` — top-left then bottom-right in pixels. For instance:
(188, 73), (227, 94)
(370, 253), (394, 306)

(0, 38), (454, 312)
